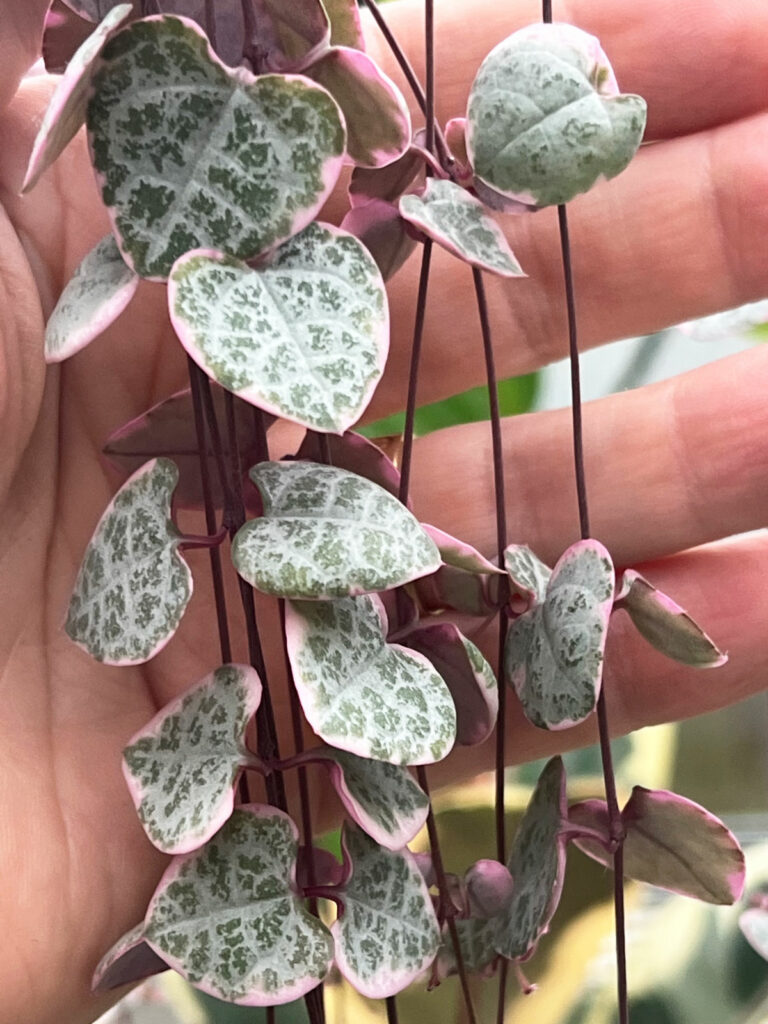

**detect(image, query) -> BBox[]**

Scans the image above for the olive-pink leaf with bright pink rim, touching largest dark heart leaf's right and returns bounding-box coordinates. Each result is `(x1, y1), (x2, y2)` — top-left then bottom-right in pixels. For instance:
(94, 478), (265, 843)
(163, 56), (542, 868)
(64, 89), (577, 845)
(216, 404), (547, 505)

(306, 46), (411, 167)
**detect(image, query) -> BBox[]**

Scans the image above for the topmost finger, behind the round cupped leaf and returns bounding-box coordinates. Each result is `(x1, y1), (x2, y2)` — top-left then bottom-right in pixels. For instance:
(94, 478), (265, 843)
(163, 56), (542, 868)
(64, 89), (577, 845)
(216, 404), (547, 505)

(367, 0), (768, 144)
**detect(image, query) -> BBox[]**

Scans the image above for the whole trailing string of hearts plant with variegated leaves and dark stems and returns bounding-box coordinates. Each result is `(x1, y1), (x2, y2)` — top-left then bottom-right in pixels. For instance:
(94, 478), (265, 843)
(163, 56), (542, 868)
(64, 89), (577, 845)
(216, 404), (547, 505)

(25, 0), (743, 1024)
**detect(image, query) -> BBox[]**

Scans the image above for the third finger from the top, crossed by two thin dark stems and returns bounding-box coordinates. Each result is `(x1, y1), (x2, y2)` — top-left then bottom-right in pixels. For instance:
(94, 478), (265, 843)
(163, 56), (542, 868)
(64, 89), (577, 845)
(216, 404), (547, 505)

(412, 346), (768, 566)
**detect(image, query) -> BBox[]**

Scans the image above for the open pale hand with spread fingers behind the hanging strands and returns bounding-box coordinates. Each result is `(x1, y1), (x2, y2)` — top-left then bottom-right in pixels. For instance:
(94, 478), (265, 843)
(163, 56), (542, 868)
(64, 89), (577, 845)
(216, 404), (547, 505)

(0, 0), (768, 1024)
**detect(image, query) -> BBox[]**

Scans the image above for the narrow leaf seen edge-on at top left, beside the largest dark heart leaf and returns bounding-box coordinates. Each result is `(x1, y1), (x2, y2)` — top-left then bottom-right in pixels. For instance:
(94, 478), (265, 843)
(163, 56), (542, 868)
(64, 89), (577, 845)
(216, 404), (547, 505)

(22, 4), (132, 193)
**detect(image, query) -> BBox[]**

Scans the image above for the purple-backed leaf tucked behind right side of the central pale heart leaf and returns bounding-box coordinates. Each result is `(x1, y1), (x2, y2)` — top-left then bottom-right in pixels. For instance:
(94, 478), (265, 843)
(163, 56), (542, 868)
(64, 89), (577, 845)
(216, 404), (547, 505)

(402, 623), (499, 745)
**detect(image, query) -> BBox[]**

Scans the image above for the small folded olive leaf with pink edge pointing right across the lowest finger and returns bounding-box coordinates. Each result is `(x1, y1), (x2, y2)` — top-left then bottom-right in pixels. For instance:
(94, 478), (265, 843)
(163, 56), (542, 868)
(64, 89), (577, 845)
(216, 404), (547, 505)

(614, 569), (728, 669)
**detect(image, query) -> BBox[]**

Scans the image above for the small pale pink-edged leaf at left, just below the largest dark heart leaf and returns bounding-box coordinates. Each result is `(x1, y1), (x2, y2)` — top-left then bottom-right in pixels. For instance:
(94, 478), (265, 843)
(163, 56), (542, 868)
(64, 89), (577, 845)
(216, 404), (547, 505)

(45, 234), (138, 362)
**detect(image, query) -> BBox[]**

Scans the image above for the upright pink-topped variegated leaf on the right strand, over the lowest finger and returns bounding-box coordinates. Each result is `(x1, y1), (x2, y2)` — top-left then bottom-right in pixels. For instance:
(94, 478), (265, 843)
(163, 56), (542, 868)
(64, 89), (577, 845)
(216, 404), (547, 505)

(504, 541), (613, 729)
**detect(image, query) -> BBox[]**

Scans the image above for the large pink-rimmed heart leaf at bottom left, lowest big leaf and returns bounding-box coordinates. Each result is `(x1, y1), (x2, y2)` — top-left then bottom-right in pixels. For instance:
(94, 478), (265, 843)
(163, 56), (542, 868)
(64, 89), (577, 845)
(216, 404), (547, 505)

(144, 806), (333, 1007)
